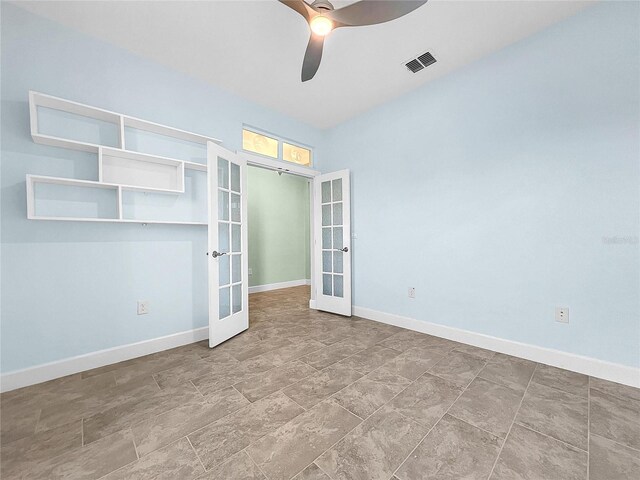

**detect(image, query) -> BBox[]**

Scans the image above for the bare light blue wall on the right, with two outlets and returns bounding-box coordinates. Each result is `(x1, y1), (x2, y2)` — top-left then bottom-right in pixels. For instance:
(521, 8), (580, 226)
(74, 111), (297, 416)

(323, 2), (640, 366)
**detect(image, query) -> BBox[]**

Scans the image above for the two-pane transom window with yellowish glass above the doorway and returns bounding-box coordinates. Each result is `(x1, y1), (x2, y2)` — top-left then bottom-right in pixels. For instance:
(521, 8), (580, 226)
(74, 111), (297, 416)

(242, 127), (313, 167)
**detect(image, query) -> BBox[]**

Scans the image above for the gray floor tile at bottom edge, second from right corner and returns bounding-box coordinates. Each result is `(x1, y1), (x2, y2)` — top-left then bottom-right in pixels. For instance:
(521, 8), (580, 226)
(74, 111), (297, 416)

(491, 424), (587, 480)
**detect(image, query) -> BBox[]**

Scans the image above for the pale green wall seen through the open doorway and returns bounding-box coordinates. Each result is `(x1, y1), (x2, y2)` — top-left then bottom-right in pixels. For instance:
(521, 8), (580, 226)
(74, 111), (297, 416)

(247, 167), (311, 286)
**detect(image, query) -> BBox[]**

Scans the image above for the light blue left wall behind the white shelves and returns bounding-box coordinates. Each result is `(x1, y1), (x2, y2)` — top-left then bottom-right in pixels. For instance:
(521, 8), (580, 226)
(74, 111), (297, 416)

(1, 2), (321, 372)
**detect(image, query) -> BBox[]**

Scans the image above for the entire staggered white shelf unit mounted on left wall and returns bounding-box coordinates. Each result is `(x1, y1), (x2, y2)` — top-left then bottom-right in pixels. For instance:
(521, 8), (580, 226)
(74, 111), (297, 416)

(26, 91), (216, 225)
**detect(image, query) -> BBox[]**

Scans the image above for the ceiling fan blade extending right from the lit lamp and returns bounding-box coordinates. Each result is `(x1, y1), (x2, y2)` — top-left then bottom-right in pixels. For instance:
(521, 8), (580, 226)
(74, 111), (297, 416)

(323, 0), (427, 27)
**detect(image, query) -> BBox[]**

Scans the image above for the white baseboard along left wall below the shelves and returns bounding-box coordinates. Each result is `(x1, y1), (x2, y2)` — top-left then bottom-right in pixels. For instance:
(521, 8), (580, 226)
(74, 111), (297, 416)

(0, 327), (209, 392)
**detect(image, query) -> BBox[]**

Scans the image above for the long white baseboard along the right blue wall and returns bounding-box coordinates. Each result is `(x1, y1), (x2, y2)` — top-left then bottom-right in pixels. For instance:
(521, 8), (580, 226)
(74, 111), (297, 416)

(353, 306), (640, 388)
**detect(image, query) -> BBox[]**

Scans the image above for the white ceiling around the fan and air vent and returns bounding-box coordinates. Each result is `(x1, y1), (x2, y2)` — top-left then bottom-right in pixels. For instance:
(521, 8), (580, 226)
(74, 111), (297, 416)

(17, 0), (592, 128)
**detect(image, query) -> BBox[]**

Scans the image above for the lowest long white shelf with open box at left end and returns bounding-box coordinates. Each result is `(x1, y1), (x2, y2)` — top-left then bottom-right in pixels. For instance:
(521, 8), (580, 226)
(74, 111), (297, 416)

(26, 175), (207, 225)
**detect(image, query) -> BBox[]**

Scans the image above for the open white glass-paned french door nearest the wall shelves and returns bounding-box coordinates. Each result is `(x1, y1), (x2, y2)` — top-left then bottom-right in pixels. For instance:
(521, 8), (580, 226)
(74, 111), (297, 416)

(207, 142), (249, 347)
